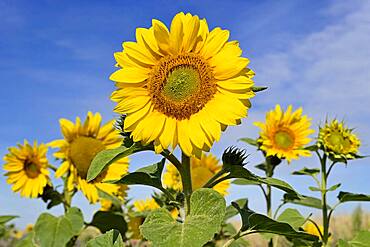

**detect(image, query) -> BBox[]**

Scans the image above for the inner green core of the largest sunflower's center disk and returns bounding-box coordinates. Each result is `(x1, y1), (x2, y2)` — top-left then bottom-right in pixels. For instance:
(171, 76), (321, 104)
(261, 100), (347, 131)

(163, 67), (201, 102)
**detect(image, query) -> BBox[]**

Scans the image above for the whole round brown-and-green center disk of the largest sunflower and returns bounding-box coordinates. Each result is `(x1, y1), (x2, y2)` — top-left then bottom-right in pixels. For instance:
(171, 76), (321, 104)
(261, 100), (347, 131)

(147, 53), (217, 120)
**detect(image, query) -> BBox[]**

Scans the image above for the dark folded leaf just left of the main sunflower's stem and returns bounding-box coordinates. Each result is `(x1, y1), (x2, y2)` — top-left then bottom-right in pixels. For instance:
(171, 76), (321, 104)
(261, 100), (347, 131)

(113, 159), (166, 190)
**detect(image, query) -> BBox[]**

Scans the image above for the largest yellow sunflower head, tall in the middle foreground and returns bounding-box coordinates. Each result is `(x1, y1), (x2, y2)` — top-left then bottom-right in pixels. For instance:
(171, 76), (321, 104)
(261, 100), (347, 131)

(110, 13), (254, 157)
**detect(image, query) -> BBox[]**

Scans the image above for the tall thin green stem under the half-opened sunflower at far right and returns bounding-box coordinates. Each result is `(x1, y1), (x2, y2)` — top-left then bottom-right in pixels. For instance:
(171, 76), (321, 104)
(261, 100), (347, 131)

(320, 154), (329, 246)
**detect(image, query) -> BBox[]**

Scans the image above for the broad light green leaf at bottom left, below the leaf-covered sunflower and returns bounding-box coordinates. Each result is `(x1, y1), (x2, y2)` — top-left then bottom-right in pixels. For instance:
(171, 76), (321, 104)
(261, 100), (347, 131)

(34, 208), (83, 247)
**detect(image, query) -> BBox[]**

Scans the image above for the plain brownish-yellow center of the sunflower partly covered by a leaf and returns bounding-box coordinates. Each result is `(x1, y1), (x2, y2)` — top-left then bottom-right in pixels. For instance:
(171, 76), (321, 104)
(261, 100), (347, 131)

(70, 136), (105, 179)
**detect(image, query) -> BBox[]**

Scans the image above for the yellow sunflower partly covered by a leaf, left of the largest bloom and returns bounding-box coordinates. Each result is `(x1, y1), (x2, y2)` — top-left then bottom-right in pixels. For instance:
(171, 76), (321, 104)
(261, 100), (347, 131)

(50, 112), (128, 203)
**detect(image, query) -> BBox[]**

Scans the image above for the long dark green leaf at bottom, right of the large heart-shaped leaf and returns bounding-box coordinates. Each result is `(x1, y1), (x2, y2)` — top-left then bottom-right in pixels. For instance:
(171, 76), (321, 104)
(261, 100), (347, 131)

(232, 202), (319, 242)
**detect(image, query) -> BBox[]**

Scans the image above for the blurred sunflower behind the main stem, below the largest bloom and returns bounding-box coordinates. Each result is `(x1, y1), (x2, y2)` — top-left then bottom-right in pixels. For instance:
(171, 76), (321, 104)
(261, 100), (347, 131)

(163, 154), (230, 195)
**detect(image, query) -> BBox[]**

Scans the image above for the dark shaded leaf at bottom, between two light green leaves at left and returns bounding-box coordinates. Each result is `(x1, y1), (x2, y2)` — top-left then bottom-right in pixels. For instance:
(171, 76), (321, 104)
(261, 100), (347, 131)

(89, 211), (127, 236)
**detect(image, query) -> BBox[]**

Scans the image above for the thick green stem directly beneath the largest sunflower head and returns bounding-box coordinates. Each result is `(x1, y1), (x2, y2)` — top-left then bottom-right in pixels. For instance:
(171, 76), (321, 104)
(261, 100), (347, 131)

(179, 152), (192, 215)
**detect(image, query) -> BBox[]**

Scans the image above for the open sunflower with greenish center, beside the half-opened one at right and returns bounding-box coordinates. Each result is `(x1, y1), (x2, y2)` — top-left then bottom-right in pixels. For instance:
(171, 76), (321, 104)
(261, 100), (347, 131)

(254, 105), (314, 162)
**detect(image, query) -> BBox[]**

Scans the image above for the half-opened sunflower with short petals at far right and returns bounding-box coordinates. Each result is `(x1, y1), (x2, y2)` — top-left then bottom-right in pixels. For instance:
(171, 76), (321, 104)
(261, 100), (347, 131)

(318, 119), (361, 159)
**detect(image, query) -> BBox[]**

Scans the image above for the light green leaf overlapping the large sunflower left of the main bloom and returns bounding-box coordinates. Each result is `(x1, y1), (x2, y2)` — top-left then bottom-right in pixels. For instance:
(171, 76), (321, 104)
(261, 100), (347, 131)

(87, 143), (152, 182)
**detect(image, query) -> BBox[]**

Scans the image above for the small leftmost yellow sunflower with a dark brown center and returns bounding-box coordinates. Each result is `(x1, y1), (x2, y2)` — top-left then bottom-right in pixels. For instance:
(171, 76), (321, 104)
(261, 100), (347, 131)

(4, 140), (51, 198)
